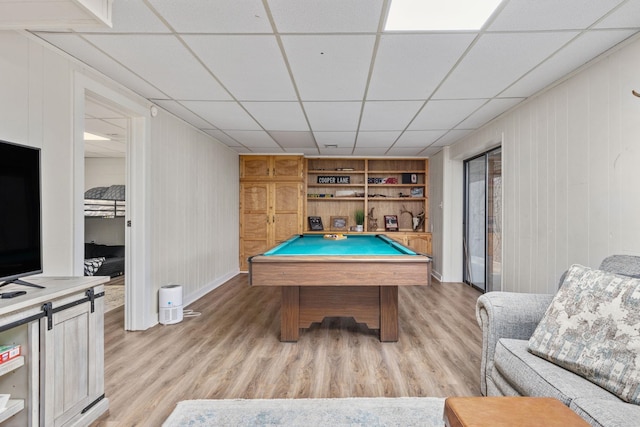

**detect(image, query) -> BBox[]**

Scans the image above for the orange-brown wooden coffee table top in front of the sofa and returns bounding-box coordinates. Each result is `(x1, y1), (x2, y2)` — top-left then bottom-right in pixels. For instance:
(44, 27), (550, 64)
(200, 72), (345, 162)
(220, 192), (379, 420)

(444, 397), (589, 427)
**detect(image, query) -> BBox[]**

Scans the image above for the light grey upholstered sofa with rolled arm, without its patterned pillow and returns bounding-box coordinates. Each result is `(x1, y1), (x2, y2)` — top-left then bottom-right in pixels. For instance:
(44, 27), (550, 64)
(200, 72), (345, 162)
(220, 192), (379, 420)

(476, 255), (640, 427)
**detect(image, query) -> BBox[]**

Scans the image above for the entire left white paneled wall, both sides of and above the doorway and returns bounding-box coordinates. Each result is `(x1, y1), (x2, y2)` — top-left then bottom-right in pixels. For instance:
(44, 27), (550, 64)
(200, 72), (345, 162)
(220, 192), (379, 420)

(0, 31), (239, 328)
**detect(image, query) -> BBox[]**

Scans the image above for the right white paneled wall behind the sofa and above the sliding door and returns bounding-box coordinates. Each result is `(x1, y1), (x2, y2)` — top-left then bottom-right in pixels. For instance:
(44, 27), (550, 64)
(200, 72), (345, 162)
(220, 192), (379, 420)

(448, 35), (640, 292)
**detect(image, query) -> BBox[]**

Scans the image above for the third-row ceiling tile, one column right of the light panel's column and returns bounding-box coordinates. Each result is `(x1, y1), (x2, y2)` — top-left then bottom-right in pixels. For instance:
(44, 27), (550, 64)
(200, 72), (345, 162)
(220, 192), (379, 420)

(408, 99), (487, 130)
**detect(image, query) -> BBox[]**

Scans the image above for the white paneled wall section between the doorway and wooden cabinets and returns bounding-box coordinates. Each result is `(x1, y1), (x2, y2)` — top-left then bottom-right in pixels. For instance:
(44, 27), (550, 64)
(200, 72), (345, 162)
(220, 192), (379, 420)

(150, 111), (239, 307)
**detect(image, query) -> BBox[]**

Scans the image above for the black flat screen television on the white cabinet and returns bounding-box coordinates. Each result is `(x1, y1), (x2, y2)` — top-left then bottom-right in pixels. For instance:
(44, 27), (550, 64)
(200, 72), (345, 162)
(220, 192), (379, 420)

(0, 141), (42, 287)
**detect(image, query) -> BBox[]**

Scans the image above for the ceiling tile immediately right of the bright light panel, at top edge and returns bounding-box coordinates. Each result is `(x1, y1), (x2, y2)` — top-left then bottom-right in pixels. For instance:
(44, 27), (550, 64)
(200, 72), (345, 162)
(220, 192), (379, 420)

(489, 0), (622, 31)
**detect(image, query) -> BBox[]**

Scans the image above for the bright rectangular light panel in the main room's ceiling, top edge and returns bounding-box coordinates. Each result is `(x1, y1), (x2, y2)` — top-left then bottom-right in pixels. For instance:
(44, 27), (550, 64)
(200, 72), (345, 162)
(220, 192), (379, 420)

(385, 0), (502, 31)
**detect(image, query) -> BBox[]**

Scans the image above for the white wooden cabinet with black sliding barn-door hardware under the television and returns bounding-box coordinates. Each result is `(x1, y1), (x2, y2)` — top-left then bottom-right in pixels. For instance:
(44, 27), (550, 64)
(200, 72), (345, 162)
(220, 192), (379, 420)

(0, 277), (109, 427)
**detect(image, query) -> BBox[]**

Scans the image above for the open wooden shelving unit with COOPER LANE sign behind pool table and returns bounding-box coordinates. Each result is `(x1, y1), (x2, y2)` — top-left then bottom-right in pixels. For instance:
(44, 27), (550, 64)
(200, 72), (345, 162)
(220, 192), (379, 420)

(304, 158), (431, 253)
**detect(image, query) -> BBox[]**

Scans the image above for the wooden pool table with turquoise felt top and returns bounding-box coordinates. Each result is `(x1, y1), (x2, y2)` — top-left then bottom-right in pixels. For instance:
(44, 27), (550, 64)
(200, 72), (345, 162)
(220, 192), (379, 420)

(249, 234), (431, 341)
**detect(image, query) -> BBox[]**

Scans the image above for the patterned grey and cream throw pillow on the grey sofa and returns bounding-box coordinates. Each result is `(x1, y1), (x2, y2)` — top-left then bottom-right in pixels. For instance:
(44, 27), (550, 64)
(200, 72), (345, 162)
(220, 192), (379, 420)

(529, 265), (640, 405)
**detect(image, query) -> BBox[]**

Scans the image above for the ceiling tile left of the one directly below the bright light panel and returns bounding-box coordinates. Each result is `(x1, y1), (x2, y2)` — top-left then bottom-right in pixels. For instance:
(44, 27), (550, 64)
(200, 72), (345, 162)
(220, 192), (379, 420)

(282, 35), (375, 101)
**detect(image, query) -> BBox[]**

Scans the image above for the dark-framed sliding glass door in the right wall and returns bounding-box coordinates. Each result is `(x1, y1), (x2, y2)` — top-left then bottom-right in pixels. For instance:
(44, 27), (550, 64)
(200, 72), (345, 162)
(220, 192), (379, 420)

(464, 148), (502, 292)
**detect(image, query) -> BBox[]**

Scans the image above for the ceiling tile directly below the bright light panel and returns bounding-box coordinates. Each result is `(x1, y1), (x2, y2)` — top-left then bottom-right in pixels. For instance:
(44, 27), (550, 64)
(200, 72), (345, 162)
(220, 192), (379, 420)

(367, 34), (475, 100)
